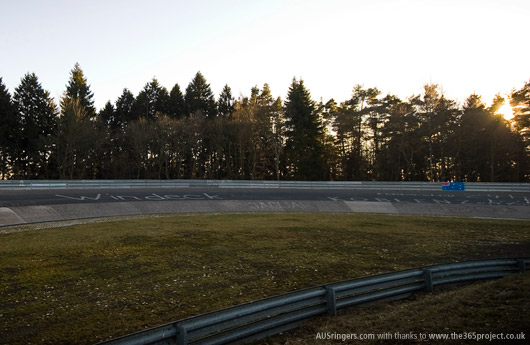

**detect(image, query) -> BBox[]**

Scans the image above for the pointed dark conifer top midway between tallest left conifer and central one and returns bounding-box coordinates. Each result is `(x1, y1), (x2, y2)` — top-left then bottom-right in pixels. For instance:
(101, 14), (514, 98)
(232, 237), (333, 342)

(184, 72), (217, 118)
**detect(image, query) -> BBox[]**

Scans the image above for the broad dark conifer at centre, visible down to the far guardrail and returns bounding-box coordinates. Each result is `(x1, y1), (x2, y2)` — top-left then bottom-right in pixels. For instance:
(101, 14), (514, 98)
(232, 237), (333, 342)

(285, 79), (327, 180)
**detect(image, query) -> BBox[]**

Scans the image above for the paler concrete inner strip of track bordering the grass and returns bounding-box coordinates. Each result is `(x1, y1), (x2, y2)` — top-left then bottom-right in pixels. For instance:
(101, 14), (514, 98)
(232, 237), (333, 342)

(0, 200), (530, 226)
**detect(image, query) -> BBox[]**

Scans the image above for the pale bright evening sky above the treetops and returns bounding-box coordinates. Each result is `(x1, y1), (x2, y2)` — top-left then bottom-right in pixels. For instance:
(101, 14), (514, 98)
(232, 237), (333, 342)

(0, 0), (530, 109)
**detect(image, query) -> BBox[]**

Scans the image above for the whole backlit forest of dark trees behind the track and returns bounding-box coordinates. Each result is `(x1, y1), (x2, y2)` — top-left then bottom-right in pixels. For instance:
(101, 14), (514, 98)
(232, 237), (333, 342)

(0, 64), (530, 182)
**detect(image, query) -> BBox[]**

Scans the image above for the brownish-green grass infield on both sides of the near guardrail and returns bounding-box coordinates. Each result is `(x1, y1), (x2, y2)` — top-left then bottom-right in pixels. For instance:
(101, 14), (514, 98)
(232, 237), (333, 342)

(0, 214), (530, 344)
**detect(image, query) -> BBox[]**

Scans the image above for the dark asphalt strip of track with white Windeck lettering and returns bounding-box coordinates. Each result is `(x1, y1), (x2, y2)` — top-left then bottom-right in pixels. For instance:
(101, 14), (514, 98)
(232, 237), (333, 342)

(0, 188), (530, 206)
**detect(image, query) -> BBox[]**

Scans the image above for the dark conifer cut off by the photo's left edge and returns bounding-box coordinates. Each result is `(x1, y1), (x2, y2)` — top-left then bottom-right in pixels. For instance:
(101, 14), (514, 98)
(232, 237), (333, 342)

(0, 78), (17, 180)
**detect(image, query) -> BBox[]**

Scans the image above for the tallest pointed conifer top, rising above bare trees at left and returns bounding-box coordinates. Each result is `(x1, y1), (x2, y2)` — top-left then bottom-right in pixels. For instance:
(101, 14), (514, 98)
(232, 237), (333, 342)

(61, 63), (96, 118)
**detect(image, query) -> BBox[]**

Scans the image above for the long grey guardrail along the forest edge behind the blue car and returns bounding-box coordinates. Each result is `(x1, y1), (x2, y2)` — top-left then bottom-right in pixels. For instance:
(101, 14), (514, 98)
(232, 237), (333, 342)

(0, 180), (530, 192)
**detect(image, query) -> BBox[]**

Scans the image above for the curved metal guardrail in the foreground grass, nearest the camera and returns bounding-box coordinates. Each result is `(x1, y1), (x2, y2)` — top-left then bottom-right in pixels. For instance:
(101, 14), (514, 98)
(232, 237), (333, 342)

(99, 258), (530, 345)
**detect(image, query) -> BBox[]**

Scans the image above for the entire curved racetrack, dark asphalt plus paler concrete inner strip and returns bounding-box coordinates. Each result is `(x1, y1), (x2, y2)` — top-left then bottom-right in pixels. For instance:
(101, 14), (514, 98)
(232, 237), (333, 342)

(0, 187), (530, 226)
